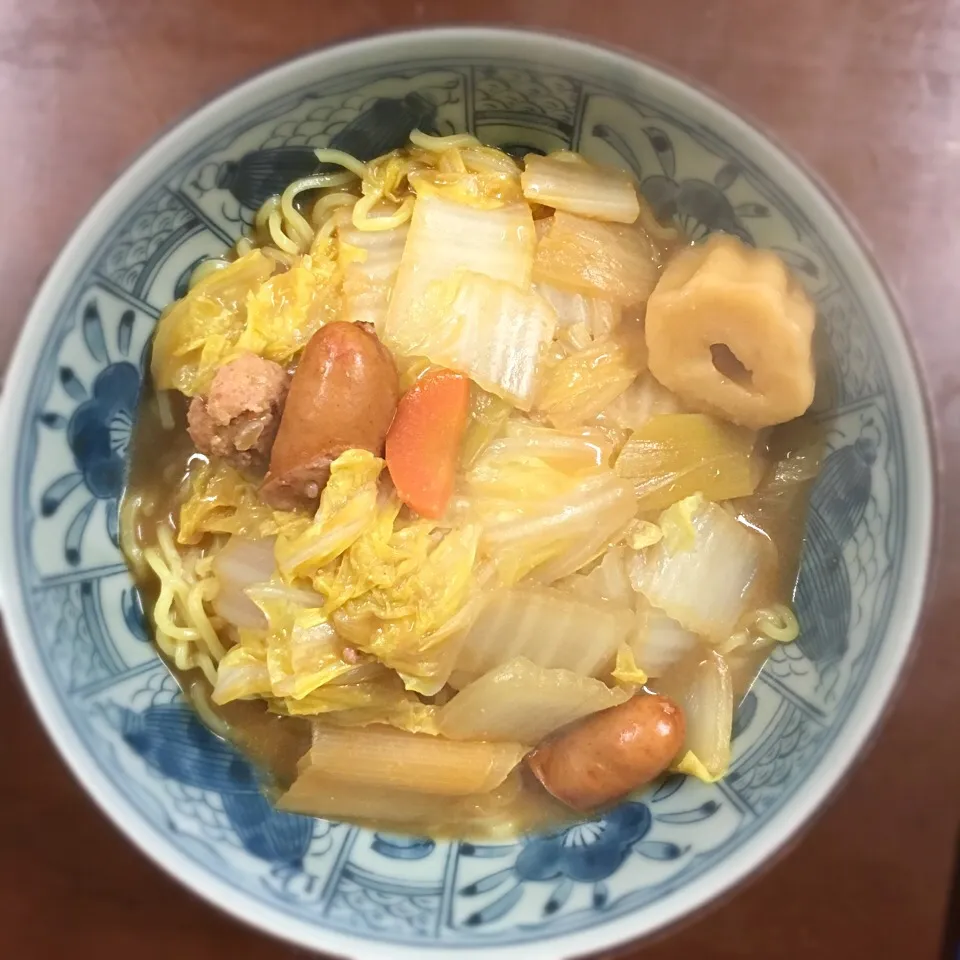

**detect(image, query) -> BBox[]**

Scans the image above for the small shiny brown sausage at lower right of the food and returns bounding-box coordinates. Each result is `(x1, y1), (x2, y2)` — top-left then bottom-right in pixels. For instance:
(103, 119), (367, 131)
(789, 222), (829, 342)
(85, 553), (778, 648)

(527, 694), (686, 813)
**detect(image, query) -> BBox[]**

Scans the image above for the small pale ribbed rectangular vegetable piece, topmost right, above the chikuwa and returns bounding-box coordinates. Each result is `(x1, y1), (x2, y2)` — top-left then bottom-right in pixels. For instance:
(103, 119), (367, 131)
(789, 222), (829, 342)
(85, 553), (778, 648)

(520, 153), (640, 223)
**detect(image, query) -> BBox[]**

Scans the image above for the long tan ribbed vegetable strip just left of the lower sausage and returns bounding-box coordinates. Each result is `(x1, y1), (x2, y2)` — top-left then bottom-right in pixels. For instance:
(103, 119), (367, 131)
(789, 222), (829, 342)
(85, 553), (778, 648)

(302, 724), (526, 796)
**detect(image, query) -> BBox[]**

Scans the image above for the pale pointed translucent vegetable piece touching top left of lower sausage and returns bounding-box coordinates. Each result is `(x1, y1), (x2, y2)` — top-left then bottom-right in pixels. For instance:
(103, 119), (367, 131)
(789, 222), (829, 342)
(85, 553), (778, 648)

(437, 657), (629, 746)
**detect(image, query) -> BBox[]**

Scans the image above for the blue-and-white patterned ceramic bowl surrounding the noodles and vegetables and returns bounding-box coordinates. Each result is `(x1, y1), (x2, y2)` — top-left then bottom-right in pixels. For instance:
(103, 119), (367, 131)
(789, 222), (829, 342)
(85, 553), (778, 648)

(0, 29), (932, 960)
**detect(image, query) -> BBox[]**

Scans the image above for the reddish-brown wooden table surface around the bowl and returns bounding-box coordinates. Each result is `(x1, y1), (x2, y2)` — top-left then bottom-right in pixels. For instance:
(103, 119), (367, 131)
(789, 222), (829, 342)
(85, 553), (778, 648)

(0, 0), (960, 960)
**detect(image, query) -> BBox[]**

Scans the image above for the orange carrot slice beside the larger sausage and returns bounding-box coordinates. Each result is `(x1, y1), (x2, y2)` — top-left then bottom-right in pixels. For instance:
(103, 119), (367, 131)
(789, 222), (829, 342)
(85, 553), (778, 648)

(386, 370), (470, 519)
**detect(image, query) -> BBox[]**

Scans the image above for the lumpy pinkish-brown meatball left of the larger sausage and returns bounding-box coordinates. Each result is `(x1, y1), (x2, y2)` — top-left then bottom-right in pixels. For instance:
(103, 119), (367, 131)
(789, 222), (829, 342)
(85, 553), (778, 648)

(187, 354), (289, 470)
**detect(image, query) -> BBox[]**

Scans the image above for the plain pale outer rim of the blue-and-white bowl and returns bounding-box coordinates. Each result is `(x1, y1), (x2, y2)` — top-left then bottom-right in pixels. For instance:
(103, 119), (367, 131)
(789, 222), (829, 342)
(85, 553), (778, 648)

(0, 25), (937, 960)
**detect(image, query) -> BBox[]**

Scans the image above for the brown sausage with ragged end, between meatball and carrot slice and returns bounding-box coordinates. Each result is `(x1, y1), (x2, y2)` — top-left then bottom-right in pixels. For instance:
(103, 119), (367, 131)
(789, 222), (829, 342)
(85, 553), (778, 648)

(260, 323), (400, 510)
